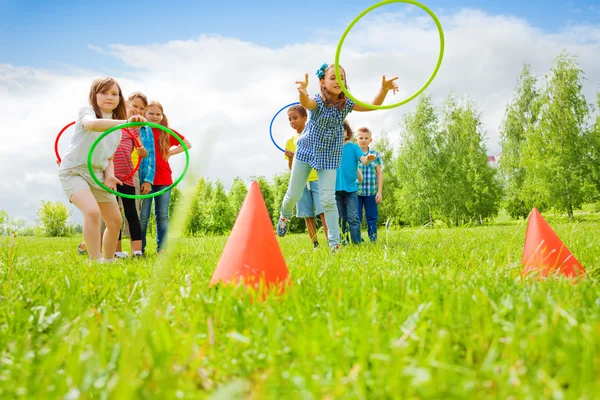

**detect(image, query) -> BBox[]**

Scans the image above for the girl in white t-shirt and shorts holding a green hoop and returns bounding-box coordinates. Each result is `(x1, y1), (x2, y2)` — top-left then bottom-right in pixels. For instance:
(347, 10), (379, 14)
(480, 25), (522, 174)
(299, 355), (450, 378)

(58, 77), (146, 262)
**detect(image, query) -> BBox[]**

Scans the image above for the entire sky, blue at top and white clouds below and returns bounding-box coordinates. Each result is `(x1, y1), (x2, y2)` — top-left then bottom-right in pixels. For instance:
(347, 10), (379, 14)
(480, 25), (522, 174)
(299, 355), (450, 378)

(0, 0), (600, 223)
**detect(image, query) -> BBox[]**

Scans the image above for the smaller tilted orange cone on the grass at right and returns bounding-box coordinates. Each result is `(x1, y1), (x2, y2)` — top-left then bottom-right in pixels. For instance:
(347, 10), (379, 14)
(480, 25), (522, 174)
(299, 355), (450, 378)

(522, 208), (585, 278)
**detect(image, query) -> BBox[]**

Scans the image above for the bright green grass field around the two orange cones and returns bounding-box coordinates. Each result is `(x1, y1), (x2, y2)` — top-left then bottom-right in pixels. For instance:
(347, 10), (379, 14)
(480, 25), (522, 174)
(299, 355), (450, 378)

(0, 223), (600, 399)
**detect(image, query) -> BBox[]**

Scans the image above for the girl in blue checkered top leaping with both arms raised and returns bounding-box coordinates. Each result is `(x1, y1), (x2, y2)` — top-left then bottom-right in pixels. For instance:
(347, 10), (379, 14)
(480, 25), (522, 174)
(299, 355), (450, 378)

(277, 64), (398, 251)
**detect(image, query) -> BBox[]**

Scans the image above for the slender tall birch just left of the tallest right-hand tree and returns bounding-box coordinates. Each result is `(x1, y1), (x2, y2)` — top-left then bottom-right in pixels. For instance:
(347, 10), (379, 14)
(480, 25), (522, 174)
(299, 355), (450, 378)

(500, 65), (539, 219)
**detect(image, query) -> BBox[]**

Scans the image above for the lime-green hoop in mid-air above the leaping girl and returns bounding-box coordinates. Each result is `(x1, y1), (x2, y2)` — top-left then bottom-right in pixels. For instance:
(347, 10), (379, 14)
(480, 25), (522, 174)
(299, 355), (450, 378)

(335, 0), (444, 110)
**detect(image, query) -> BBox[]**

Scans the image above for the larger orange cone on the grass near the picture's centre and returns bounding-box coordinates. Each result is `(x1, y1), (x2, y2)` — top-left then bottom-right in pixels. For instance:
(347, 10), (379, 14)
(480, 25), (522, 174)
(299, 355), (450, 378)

(209, 181), (289, 296)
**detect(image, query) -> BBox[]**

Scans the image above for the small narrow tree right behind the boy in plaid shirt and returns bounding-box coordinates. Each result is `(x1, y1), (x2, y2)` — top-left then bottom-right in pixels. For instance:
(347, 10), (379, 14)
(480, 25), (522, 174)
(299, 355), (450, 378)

(373, 132), (400, 228)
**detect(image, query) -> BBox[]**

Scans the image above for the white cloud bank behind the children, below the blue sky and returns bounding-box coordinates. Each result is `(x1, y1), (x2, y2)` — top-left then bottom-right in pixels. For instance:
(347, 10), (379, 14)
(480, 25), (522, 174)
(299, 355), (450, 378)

(0, 10), (600, 225)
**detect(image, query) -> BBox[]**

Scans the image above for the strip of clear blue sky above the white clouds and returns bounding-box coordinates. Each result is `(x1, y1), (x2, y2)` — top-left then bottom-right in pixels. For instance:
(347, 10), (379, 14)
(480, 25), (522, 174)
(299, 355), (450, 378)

(0, 0), (600, 69)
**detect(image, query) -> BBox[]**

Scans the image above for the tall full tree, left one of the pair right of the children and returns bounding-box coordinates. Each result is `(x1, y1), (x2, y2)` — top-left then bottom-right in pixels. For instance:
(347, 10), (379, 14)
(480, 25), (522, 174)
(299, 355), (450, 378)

(396, 95), (440, 226)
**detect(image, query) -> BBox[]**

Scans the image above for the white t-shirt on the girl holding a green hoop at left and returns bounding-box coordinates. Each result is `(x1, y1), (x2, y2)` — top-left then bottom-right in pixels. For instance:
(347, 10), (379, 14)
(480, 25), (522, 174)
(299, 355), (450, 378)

(60, 106), (121, 170)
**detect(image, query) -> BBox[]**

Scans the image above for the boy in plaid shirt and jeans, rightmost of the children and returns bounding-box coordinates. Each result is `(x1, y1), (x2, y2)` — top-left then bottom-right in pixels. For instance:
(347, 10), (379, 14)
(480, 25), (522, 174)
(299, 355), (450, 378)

(357, 127), (383, 242)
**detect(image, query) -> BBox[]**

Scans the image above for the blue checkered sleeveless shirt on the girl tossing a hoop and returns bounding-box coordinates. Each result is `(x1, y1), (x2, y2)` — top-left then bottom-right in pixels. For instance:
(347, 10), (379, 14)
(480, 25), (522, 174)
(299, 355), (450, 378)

(296, 94), (354, 171)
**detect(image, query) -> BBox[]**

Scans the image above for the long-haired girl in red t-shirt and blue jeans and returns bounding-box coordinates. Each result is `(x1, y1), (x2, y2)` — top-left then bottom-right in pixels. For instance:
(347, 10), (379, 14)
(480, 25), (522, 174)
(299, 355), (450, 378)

(140, 101), (192, 253)
